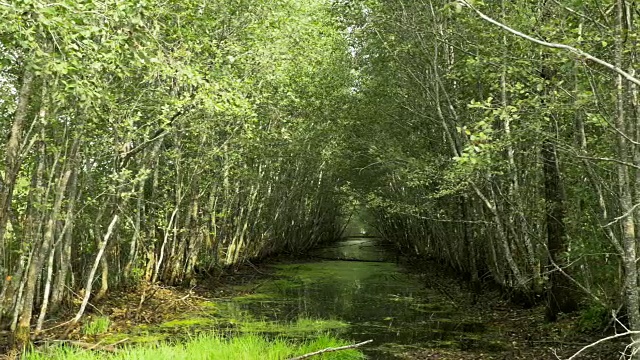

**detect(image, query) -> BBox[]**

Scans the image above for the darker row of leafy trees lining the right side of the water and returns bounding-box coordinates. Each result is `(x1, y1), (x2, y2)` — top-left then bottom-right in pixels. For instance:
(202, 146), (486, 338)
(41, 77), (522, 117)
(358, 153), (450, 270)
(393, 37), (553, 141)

(346, 1), (640, 354)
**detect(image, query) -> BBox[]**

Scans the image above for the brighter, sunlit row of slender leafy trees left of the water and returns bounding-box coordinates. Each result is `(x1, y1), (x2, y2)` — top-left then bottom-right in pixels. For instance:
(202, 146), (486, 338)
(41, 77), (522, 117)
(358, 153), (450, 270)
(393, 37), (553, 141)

(0, 0), (352, 344)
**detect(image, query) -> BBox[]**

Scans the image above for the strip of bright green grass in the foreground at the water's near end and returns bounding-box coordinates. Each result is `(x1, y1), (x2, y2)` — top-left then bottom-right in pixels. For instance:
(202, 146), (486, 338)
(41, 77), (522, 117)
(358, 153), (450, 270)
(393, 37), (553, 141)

(22, 334), (364, 360)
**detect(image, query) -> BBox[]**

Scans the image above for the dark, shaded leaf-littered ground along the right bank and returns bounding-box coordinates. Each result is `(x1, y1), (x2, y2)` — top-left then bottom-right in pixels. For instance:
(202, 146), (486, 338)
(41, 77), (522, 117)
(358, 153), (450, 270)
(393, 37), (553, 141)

(403, 262), (627, 360)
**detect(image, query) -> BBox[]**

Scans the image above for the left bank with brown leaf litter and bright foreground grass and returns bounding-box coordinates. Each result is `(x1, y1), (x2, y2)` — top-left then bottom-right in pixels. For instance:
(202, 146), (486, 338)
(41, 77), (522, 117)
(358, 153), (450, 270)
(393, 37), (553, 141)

(0, 265), (363, 360)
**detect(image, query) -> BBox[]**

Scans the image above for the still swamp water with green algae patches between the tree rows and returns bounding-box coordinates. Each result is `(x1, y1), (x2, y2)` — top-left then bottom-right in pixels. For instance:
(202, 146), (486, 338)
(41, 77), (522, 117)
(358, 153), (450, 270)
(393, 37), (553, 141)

(107, 238), (502, 360)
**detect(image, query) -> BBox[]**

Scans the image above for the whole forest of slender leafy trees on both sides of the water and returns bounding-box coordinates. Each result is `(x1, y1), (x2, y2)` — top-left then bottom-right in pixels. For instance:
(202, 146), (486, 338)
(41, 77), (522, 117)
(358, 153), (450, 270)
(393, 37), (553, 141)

(0, 0), (640, 359)
